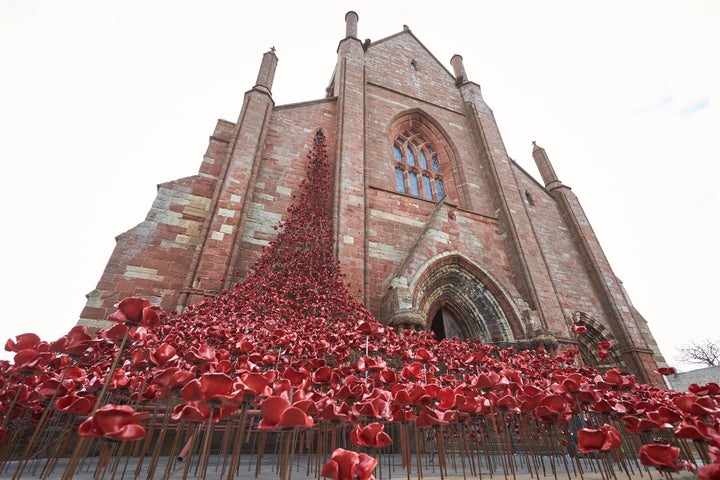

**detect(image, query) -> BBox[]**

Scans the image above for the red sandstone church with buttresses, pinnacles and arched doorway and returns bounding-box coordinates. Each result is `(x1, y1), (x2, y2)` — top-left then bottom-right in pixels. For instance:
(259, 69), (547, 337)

(80, 12), (664, 385)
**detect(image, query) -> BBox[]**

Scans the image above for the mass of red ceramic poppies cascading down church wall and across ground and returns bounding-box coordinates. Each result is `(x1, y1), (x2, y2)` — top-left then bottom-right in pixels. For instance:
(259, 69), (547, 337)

(0, 130), (720, 480)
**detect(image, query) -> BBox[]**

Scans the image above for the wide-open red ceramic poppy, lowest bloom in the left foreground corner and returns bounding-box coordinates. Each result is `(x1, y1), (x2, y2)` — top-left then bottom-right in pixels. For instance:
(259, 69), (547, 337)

(78, 403), (147, 441)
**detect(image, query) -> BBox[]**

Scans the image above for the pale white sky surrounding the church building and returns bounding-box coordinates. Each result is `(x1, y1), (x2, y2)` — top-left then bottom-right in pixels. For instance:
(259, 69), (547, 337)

(0, 0), (720, 369)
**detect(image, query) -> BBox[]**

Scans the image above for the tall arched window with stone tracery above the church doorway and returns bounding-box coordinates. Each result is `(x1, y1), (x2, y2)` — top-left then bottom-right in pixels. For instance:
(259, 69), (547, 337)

(393, 130), (445, 201)
